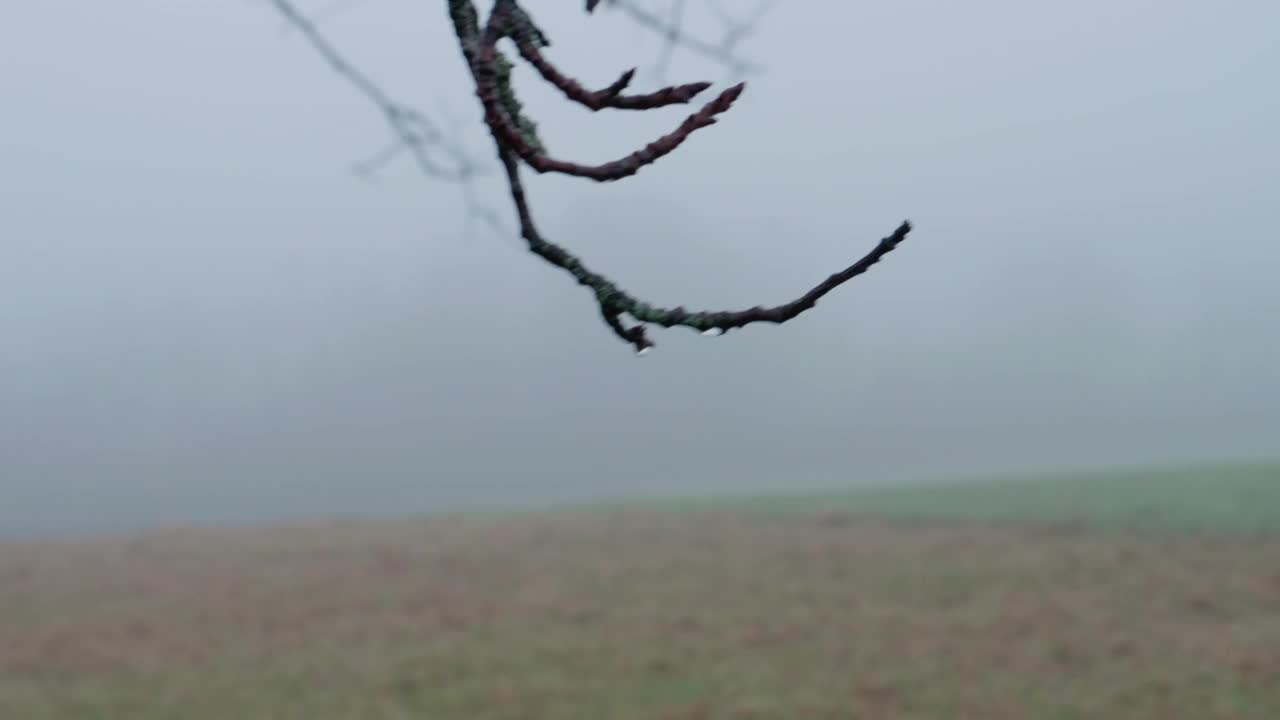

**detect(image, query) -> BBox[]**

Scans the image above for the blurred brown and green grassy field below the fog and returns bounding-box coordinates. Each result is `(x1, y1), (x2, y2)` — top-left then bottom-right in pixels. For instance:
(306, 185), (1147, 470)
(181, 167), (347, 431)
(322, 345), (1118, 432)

(0, 466), (1280, 720)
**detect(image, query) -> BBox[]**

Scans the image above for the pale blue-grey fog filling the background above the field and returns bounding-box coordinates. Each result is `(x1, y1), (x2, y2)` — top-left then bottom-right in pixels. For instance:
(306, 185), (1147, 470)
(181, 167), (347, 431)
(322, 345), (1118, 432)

(0, 0), (1280, 534)
